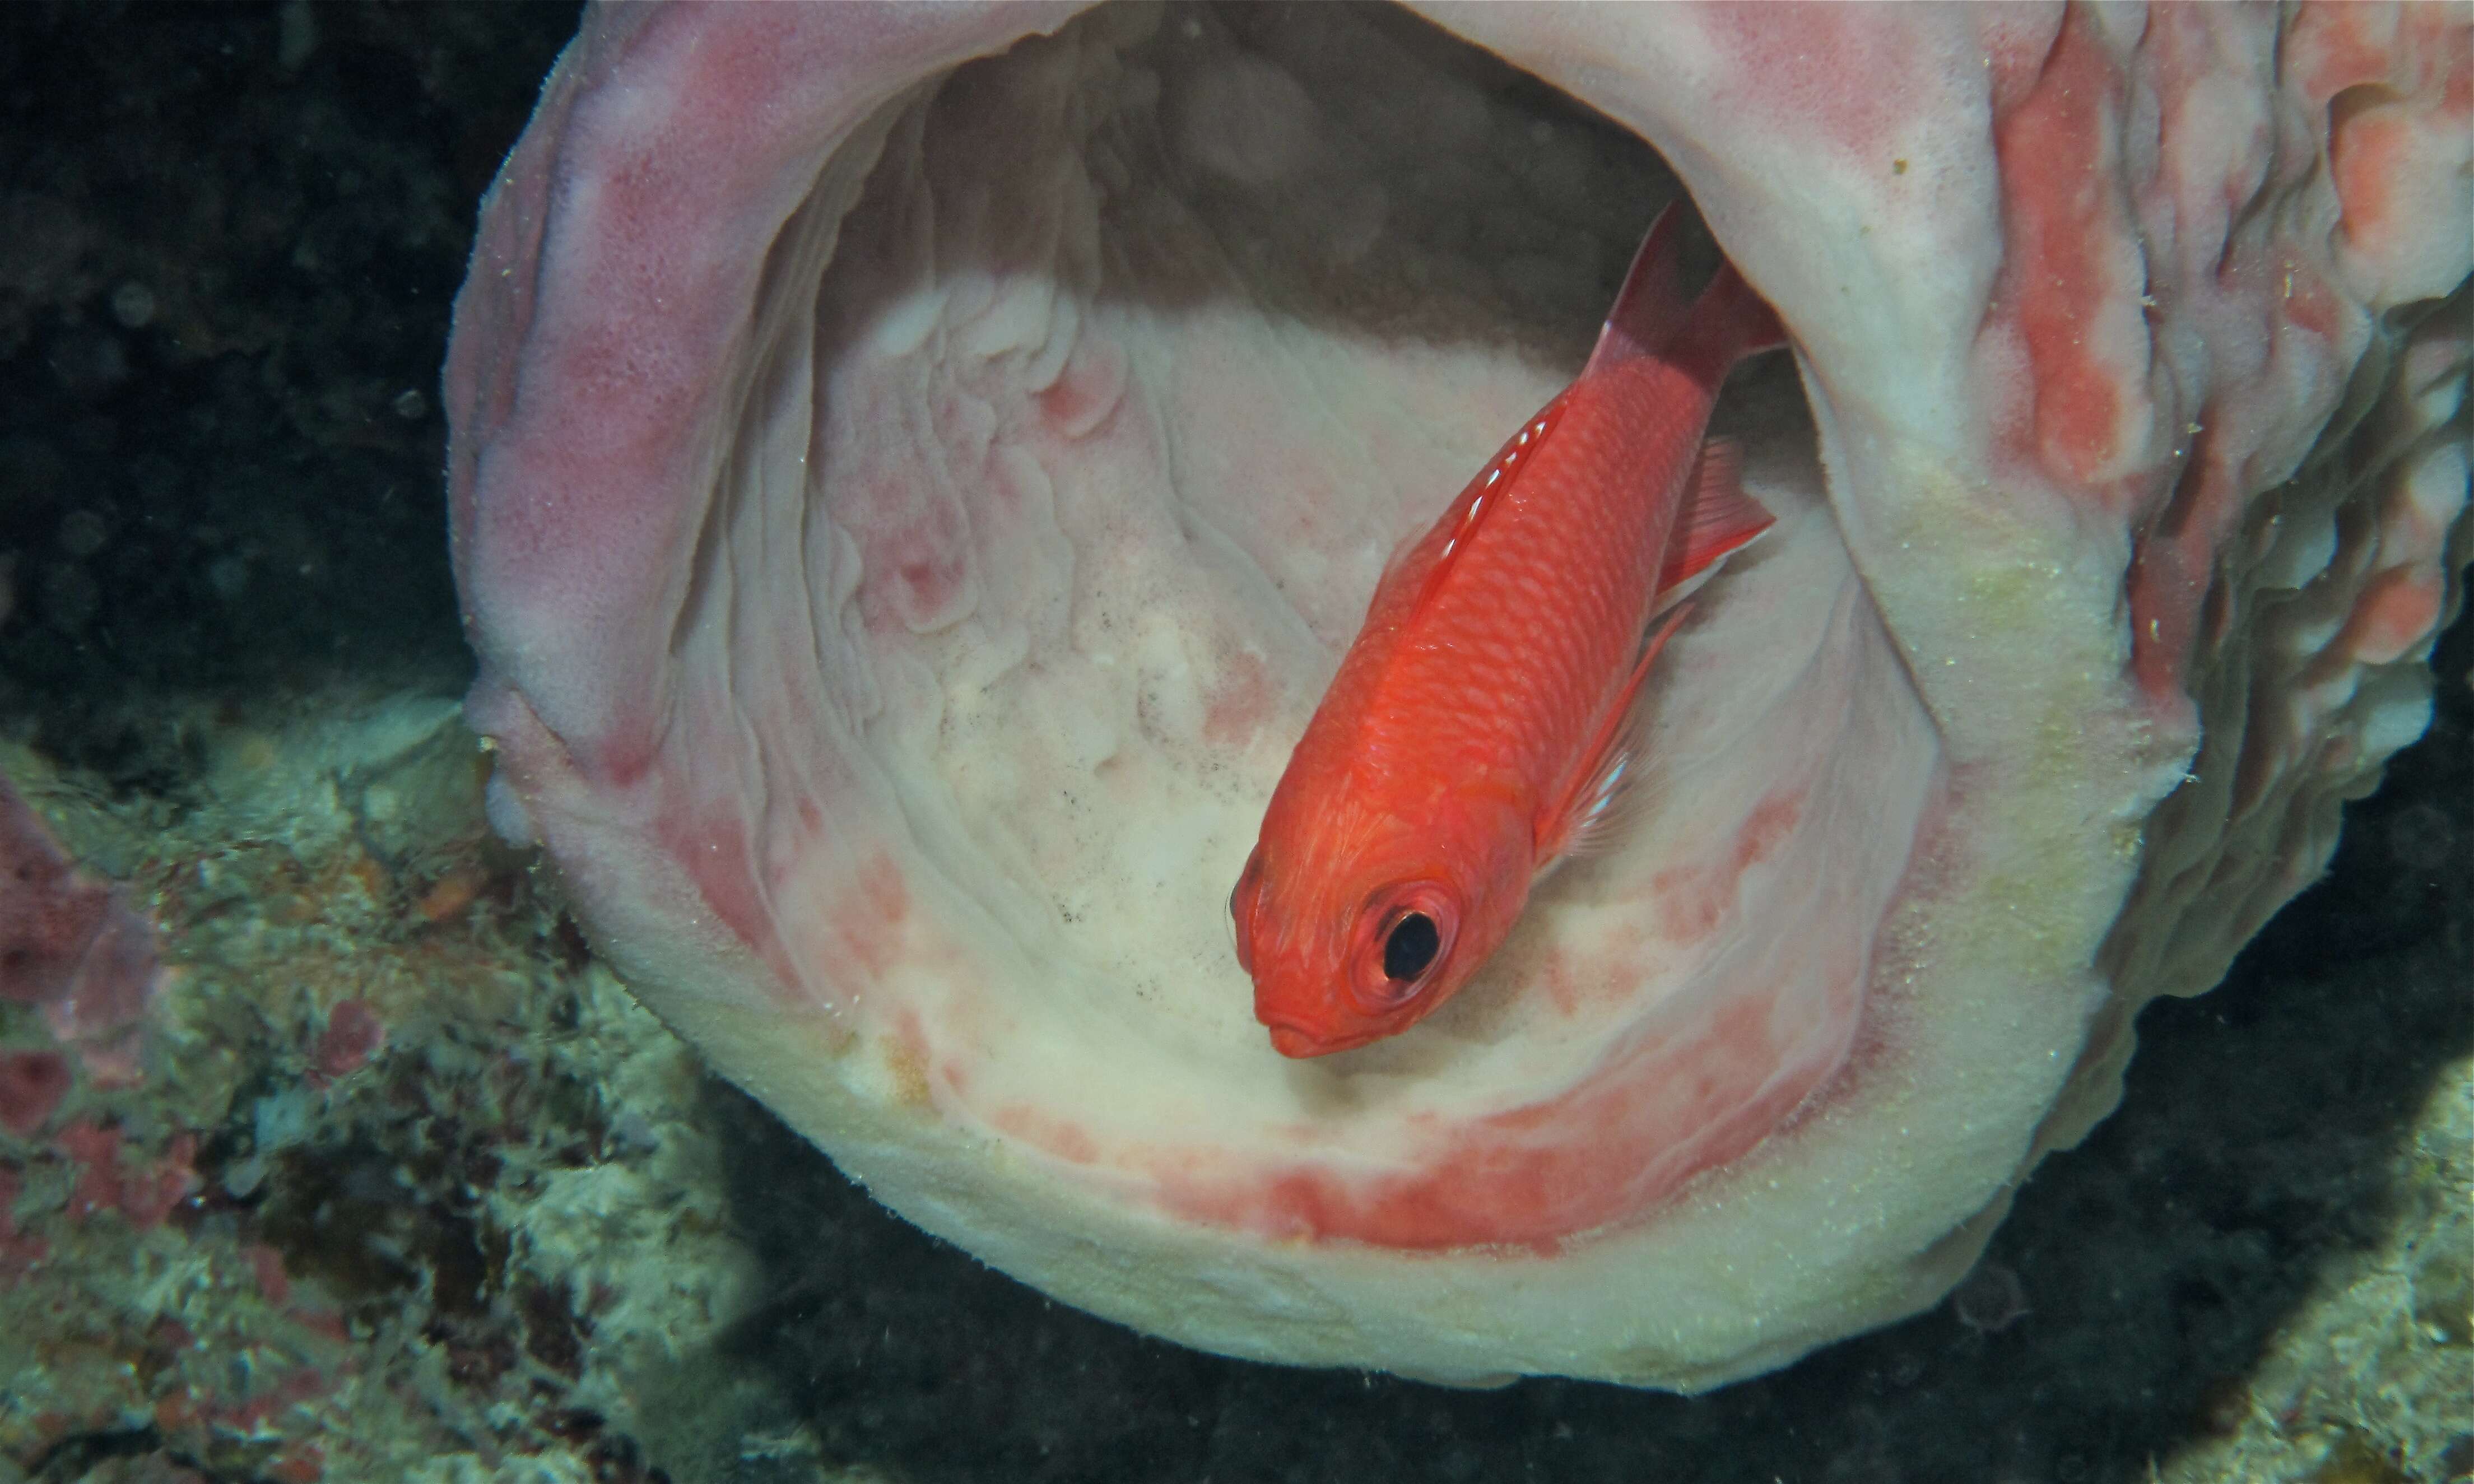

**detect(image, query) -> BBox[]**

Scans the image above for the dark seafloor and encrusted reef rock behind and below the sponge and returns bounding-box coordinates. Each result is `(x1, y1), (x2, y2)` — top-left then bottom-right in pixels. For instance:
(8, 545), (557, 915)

(0, 0), (2474, 1484)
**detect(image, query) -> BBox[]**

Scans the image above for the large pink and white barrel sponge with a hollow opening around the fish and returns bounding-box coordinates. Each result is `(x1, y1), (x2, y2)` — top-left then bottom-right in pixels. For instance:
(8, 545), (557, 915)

(448, 5), (2464, 1388)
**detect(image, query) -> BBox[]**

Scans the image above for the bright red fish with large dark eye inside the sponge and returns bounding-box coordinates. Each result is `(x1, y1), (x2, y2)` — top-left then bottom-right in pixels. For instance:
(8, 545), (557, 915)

(1230, 208), (1786, 1056)
